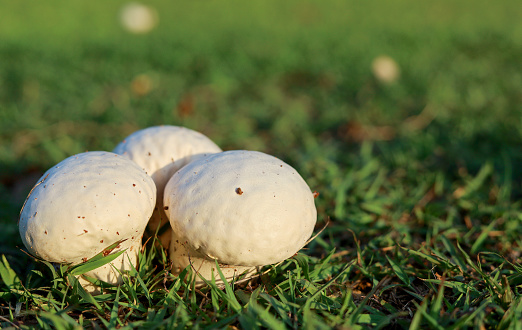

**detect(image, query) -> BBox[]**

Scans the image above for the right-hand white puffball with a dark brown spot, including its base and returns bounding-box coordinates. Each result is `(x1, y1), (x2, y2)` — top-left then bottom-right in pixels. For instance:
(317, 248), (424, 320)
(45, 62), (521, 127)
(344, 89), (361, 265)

(164, 150), (317, 285)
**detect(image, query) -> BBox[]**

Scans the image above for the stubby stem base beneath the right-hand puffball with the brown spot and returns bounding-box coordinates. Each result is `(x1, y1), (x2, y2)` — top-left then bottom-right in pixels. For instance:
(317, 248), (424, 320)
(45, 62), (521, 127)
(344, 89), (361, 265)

(169, 234), (259, 287)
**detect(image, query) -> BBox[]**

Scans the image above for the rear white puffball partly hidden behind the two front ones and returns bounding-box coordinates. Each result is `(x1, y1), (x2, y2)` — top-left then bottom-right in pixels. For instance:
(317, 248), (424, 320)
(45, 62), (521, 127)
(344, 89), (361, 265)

(113, 126), (221, 248)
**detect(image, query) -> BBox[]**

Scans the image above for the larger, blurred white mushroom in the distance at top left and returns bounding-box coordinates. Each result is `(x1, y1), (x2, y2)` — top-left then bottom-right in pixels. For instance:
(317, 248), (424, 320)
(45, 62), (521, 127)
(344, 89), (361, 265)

(120, 2), (158, 34)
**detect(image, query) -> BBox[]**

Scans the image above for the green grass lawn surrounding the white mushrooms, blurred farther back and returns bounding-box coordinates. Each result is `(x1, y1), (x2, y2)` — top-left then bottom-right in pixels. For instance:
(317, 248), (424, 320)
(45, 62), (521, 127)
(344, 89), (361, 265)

(0, 0), (522, 329)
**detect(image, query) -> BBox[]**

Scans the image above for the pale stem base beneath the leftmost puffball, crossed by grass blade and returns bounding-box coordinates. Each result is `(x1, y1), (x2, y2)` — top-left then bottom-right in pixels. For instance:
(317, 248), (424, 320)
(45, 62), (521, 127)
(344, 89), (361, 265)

(77, 237), (141, 295)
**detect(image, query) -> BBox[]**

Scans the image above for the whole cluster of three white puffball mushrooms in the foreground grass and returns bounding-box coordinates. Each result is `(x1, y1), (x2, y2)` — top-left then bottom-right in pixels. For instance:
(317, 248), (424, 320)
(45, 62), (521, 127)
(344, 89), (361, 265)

(19, 126), (317, 293)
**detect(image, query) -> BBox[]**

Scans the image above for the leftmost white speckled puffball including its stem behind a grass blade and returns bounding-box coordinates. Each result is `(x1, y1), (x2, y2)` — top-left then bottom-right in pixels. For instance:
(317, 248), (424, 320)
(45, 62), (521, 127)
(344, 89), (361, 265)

(18, 151), (156, 292)
